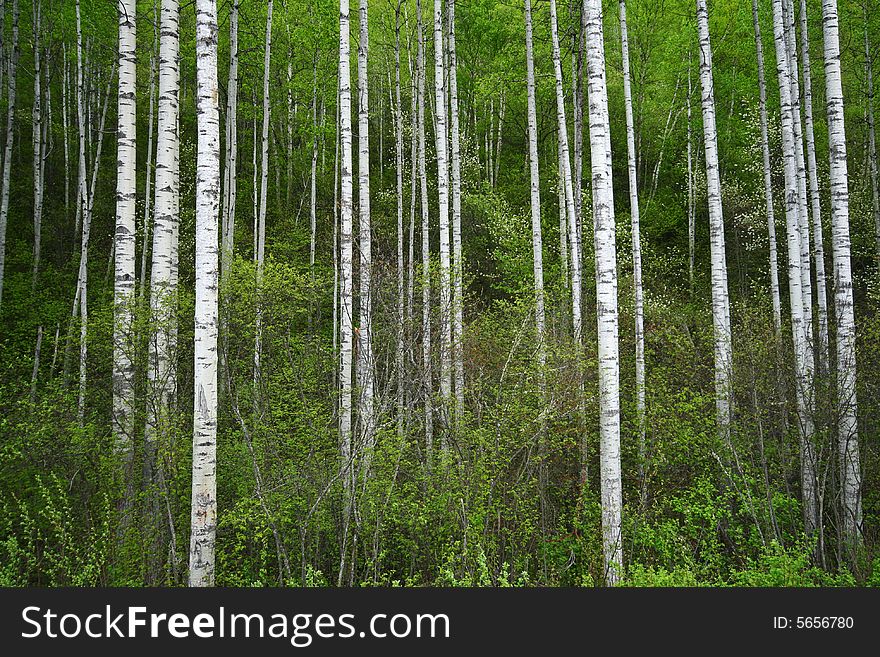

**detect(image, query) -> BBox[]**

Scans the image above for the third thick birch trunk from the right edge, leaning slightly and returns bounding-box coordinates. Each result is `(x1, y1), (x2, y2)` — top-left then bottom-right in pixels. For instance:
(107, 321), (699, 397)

(697, 0), (733, 445)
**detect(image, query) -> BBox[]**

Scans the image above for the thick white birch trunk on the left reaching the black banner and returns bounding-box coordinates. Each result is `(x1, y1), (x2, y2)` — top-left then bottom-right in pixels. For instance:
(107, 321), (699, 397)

(189, 0), (220, 586)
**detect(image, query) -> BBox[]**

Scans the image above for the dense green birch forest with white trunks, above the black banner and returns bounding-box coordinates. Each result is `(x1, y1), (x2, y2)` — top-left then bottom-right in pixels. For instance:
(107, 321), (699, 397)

(0, 0), (880, 586)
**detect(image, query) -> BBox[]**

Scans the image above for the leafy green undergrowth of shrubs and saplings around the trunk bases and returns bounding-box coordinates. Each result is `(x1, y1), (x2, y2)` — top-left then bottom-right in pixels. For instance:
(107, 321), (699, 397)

(0, 149), (880, 586)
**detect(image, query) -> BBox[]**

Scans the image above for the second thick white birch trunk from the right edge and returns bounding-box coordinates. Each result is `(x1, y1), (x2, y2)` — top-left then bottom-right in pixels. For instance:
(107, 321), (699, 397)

(773, 0), (817, 534)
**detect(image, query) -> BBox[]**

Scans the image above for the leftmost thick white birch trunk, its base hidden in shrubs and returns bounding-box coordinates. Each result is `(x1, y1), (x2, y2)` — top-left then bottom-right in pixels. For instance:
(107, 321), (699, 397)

(113, 0), (137, 460)
